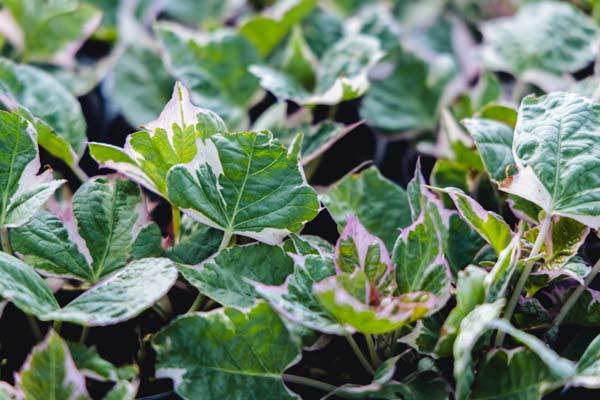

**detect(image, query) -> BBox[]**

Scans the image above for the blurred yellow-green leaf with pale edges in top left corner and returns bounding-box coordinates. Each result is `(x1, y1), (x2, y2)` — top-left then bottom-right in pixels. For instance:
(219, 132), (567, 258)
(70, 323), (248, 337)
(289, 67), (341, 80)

(0, 0), (101, 67)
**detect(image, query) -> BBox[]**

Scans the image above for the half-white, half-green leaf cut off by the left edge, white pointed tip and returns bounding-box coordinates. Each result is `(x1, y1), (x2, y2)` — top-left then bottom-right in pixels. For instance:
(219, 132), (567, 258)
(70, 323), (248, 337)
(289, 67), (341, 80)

(0, 111), (65, 228)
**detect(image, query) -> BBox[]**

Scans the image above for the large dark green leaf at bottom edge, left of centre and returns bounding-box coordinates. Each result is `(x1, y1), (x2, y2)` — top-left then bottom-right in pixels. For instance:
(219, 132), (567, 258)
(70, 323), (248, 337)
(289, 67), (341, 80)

(152, 302), (300, 400)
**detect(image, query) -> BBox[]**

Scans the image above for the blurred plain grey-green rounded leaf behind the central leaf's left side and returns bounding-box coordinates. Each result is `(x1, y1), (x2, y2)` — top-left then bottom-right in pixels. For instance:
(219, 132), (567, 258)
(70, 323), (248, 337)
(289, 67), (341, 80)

(104, 45), (175, 126)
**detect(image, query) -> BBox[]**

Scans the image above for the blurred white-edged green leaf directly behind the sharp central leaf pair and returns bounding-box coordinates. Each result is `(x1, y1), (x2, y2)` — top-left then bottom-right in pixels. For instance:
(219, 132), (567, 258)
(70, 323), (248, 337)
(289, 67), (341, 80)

(155, 22), (260, 128)
